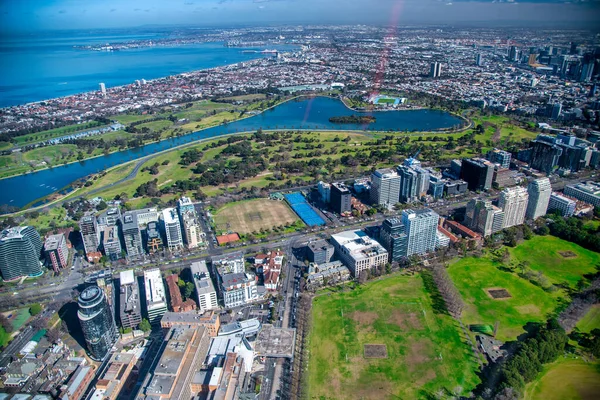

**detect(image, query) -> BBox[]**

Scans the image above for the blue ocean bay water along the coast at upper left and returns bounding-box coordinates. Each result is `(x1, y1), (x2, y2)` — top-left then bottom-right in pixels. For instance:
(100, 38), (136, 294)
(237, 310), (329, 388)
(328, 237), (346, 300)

(0, 32), (295, 107)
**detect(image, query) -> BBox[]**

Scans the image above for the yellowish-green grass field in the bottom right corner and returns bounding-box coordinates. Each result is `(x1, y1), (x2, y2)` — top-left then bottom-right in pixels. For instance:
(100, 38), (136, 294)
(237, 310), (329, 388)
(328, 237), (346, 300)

(523, 358), (600, 400)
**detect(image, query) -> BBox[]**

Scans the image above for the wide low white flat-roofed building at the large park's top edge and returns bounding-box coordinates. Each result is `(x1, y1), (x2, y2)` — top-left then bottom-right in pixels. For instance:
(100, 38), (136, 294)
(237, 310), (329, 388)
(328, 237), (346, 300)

(331, 230), (388, 277)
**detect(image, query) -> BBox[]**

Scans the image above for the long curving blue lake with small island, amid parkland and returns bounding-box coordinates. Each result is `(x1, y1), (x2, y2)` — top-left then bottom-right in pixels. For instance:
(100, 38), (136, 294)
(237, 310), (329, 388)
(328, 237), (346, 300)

(0, 97), (462, 207)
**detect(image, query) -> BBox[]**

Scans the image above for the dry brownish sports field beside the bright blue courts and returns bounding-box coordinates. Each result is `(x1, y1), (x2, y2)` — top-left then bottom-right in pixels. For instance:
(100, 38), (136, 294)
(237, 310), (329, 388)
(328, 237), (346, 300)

(214, 199), (299, 235)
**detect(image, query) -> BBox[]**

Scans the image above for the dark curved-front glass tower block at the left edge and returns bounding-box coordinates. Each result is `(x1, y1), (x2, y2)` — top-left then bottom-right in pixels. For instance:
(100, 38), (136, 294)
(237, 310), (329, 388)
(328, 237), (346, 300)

(0, 226), (43, 281)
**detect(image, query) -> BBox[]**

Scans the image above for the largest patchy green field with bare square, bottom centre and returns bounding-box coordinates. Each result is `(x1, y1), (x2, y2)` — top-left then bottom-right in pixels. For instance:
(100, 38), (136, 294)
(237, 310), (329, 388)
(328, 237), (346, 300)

(308, 275), (479, 399)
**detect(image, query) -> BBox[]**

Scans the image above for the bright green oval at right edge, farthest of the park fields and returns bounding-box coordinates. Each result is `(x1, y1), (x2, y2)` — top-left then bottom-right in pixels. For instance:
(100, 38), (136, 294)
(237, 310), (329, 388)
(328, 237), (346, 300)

(510, 236), (600, 287)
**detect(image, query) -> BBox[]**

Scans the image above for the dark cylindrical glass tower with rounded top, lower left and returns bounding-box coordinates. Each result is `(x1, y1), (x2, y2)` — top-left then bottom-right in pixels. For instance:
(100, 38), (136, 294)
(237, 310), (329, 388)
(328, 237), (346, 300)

(77, 285), (118, 361)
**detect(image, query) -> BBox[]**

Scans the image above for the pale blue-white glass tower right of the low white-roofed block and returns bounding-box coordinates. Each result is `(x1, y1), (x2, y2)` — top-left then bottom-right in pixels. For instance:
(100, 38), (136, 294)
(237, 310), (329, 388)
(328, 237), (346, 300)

(402, 208), (440, 257)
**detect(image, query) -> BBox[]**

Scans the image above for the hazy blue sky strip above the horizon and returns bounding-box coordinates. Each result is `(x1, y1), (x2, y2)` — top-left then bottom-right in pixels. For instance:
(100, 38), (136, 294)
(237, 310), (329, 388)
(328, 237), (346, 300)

(0, 0), (600, 34)
